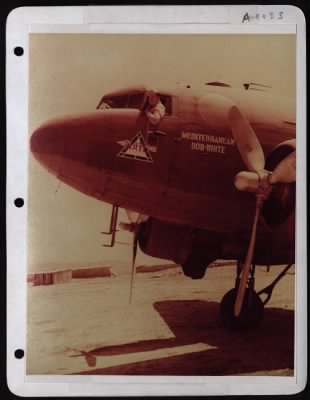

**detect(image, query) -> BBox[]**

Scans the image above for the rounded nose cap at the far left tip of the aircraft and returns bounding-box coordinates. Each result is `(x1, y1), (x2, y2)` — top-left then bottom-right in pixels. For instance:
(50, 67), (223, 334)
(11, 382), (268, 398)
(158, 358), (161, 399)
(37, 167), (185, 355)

(30, 123), (65, 173)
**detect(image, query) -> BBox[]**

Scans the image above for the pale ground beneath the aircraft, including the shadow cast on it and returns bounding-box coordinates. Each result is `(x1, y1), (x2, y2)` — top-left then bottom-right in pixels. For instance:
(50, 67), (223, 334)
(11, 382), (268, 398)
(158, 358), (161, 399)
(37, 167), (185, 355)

(26, 265), (295, 376)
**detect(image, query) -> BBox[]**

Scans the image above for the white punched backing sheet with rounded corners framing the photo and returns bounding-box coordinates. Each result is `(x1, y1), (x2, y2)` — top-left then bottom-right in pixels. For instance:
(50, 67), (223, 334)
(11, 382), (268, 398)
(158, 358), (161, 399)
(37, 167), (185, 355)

(6, 6), (307, 396)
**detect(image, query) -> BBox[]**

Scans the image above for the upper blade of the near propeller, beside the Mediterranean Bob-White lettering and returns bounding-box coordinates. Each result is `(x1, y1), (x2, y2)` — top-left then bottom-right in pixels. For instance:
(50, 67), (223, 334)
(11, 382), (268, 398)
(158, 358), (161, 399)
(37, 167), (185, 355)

(228, 106), (265, 172)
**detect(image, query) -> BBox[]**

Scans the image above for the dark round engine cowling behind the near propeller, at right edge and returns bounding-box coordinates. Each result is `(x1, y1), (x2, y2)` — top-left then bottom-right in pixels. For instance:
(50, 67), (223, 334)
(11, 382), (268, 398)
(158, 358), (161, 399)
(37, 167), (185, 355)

(262, 139), (296, 226)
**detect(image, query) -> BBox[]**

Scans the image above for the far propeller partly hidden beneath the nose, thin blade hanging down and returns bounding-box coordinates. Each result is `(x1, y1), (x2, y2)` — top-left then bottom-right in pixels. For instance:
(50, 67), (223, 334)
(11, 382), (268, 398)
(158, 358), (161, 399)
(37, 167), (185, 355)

(119, 209), (149, 304)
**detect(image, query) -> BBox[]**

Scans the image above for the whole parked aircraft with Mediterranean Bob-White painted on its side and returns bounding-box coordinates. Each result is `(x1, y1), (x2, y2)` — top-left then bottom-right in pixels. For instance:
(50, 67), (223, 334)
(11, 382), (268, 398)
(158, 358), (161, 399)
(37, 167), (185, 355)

(31, 81), (296, 328)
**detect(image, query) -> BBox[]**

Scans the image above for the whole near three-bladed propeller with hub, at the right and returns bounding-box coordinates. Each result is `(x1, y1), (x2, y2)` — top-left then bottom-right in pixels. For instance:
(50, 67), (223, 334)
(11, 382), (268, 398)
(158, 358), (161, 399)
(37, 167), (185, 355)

(228, 105), (296, 317)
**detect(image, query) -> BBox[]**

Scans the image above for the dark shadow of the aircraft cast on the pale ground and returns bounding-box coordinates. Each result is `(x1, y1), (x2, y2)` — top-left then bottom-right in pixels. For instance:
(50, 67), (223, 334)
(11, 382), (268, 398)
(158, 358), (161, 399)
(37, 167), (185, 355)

(77, 300), (294, 376)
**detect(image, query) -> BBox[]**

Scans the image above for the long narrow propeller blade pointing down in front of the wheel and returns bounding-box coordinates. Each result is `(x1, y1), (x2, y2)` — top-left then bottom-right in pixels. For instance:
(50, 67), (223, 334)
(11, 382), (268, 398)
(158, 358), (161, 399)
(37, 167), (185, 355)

(234, 197), (262, 317)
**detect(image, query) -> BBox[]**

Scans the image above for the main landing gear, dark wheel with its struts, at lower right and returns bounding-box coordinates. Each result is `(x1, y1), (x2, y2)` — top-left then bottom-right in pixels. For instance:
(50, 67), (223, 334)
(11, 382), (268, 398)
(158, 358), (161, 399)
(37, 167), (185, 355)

(220, 261), (293, 330)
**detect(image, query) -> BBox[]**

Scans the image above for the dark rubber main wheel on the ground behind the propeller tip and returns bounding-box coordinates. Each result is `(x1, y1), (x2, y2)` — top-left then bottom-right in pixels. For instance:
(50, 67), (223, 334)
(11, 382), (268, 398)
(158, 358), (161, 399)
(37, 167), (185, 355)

(220, 288), (264, 330)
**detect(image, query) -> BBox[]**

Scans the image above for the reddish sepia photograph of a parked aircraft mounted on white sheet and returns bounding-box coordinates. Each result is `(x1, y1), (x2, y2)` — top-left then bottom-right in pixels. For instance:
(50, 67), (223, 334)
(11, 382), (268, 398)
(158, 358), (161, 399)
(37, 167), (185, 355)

(25, 33), (296, 378)
